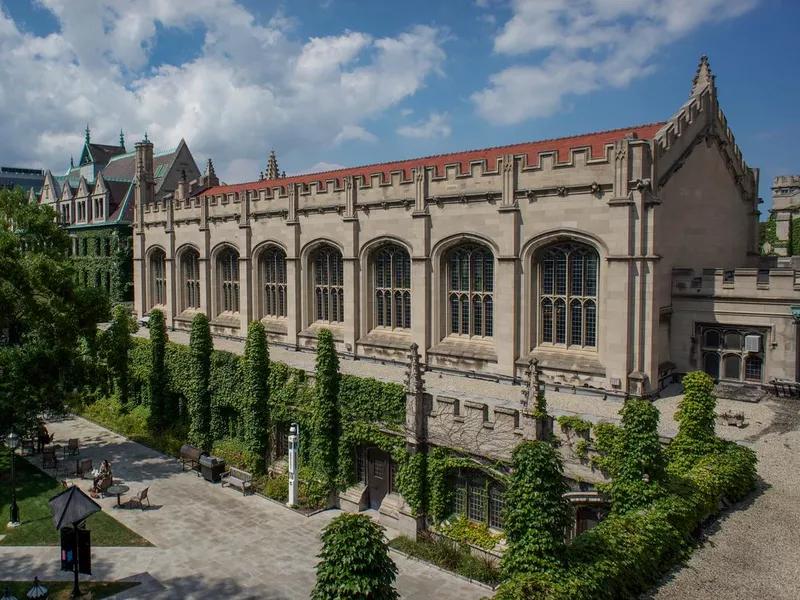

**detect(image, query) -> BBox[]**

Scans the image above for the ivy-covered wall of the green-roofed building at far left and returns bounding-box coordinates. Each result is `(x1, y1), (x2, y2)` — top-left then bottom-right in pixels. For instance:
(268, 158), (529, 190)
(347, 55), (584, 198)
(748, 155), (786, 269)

(70, 225), (133, 302)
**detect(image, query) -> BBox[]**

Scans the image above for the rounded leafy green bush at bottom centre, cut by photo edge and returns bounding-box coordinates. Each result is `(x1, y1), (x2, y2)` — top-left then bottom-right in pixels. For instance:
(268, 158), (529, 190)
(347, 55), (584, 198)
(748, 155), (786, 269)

(311, 513), (400, 600)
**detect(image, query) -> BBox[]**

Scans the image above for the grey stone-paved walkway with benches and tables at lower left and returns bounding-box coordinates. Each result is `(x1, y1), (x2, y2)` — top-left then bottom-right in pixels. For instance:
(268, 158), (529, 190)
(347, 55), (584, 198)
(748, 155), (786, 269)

(0, 418), (490, 600)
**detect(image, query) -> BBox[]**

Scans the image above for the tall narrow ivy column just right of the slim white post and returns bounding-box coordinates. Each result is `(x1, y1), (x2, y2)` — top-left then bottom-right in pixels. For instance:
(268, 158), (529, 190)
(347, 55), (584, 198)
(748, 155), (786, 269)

(311, 329), (341, 489)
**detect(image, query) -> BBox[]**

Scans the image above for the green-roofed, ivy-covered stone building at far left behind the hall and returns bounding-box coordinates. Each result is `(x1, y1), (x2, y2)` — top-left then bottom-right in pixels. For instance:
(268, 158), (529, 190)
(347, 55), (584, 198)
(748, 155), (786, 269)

(38, 126), (200, 302)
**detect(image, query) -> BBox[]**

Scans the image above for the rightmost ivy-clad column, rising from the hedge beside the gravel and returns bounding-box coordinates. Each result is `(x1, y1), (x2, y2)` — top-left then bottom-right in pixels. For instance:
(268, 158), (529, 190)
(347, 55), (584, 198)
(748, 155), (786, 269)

(667, 371), (721, 475)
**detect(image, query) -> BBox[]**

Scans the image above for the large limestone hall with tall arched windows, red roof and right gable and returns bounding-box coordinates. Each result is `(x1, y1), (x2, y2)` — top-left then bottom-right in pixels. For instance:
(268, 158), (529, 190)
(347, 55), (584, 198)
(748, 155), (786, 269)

(134, 58), (800, 396)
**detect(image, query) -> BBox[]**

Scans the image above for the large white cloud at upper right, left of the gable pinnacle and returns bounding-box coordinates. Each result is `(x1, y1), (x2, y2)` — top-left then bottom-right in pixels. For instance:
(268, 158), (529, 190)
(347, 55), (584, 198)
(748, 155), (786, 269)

(472, 0), (759, 124)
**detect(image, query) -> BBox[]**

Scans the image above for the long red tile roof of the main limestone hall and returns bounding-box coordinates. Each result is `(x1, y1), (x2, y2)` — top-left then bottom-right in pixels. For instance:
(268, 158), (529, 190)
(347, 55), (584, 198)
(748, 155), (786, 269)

(197, 122), (665, 195)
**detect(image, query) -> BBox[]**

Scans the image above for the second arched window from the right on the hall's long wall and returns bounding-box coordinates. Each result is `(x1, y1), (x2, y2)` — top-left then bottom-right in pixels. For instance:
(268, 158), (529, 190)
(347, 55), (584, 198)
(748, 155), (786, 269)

(447, 244), (494, 338)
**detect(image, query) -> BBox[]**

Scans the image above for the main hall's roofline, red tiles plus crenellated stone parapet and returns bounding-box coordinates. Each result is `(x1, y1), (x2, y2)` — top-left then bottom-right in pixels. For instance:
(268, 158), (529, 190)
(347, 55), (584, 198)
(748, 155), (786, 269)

(148, 123), (662, 223)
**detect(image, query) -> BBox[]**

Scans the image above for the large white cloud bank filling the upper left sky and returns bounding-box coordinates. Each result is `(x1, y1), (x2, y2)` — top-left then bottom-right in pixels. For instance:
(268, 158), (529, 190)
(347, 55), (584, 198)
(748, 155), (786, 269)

(0, 0), (446, 181)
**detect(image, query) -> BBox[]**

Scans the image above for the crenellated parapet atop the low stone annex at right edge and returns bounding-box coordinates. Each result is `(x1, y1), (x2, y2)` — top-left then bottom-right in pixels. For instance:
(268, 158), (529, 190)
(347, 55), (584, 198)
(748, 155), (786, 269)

(672, 269), (800, 300)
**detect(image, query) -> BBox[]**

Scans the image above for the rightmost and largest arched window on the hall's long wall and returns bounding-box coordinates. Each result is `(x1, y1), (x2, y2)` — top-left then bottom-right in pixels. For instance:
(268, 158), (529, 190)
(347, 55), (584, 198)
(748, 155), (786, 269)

(538, 243), (599, 348)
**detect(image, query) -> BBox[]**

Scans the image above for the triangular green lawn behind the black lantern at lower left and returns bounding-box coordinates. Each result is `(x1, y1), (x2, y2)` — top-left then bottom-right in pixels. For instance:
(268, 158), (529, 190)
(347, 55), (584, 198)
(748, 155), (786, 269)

(0, 449), (152, 546)
